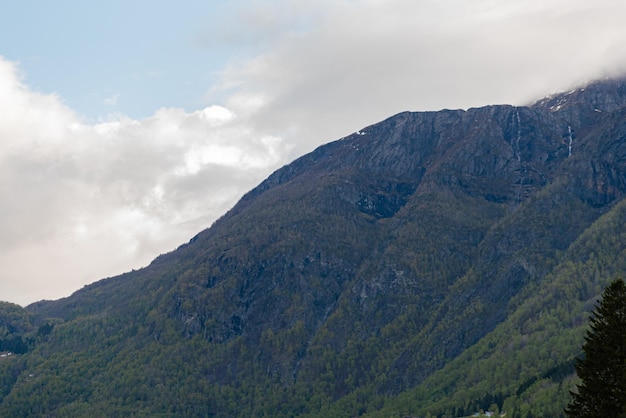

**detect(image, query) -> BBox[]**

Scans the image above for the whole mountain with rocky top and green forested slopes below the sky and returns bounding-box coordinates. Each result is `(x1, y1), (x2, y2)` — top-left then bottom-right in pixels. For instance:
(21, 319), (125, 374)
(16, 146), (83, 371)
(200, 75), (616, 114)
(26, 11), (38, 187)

(0, 79), (626, 417)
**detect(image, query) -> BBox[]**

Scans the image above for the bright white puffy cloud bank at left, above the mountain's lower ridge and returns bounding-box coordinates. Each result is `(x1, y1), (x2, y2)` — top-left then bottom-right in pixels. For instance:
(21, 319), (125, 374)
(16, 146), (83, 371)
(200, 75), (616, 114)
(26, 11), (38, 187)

(0, 59), (288, 304)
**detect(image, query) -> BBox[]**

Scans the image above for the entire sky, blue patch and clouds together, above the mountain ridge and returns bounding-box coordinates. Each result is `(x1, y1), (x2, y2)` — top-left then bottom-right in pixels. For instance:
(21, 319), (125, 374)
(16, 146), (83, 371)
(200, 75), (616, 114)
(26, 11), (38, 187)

(0, 0), (626, 306)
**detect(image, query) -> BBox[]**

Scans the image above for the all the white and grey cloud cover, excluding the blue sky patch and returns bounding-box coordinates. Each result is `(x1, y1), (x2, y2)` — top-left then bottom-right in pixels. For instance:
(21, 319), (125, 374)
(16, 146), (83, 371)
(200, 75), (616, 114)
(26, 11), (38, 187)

(0, 0), (626, 303)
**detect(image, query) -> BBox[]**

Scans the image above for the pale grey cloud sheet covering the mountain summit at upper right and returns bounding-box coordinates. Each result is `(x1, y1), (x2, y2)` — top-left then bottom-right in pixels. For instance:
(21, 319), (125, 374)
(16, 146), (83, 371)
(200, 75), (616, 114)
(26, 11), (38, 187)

(207, 0), (626, 156)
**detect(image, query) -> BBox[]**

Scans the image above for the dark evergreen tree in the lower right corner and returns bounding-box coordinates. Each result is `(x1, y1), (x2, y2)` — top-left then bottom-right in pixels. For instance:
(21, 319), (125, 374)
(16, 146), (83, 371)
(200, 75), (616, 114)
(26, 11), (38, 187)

(565, 279), (626, 418)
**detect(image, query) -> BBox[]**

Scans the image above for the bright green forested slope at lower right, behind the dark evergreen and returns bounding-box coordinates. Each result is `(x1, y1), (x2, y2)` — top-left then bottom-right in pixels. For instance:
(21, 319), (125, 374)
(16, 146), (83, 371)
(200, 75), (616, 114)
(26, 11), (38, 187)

(371, 197), (626, 417)
